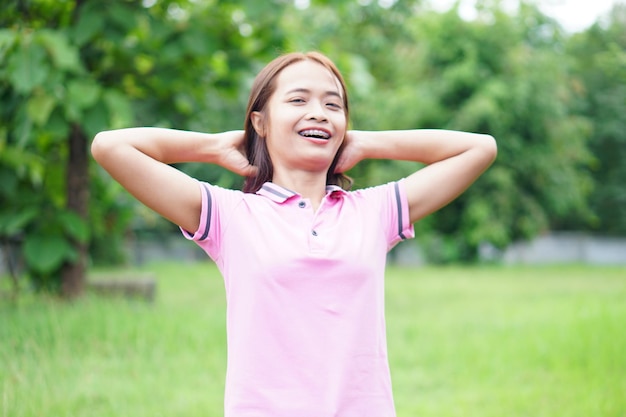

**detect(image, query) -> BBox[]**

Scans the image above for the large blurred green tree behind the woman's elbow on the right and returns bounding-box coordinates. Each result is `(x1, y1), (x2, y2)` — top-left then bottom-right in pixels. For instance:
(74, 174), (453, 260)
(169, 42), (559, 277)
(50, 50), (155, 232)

(408, 3), (591, 256)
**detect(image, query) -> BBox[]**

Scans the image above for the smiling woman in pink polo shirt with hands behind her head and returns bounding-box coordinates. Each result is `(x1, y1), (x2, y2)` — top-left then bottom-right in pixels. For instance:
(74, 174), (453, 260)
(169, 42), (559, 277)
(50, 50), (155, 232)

(92, 52), (496, 417)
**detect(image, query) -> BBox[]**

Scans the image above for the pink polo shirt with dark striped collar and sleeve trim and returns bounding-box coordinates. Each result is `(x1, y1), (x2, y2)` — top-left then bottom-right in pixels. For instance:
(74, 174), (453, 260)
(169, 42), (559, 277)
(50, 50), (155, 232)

(183, 180), (414, 417)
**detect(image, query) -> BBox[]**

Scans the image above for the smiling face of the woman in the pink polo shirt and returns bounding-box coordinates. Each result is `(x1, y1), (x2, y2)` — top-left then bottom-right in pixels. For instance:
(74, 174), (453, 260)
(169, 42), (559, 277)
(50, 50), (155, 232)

(252, 60), (347, 174)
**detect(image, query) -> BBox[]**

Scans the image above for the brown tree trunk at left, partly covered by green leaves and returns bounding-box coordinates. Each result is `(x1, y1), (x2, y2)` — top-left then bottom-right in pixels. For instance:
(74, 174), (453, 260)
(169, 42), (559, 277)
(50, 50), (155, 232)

(61, 124), (89, 298)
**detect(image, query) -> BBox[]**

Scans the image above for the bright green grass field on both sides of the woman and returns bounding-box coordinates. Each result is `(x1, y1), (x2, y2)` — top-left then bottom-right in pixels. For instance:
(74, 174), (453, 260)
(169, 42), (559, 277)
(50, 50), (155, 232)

(0, 263), (626, 417)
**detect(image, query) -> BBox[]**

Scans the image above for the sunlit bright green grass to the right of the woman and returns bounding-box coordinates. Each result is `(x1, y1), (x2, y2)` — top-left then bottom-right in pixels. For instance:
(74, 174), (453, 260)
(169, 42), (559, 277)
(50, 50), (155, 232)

(387, 267), (626, 417)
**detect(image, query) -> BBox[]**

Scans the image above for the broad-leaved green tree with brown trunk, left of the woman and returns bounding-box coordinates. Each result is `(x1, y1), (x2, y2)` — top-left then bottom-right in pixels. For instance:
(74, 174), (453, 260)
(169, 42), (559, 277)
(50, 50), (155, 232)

(0, 0), (288, 297)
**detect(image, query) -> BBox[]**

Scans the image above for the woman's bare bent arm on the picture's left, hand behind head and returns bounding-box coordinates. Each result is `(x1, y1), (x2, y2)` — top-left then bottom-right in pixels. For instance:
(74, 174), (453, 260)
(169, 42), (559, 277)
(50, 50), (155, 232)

(91, 127), (254, 232)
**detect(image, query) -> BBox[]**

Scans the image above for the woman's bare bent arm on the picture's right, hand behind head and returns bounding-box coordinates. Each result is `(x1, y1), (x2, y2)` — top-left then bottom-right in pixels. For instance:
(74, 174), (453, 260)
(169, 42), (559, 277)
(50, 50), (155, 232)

(337, 129), (498, 223)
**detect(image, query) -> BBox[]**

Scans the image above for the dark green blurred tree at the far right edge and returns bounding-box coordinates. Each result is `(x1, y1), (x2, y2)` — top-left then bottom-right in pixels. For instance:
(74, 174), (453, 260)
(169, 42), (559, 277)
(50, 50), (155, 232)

(568, 4), (626, 236)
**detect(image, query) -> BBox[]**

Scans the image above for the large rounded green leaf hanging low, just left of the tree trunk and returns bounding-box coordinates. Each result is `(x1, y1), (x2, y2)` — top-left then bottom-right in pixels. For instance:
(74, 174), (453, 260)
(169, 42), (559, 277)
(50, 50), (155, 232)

(23, 234), (75, 274)
